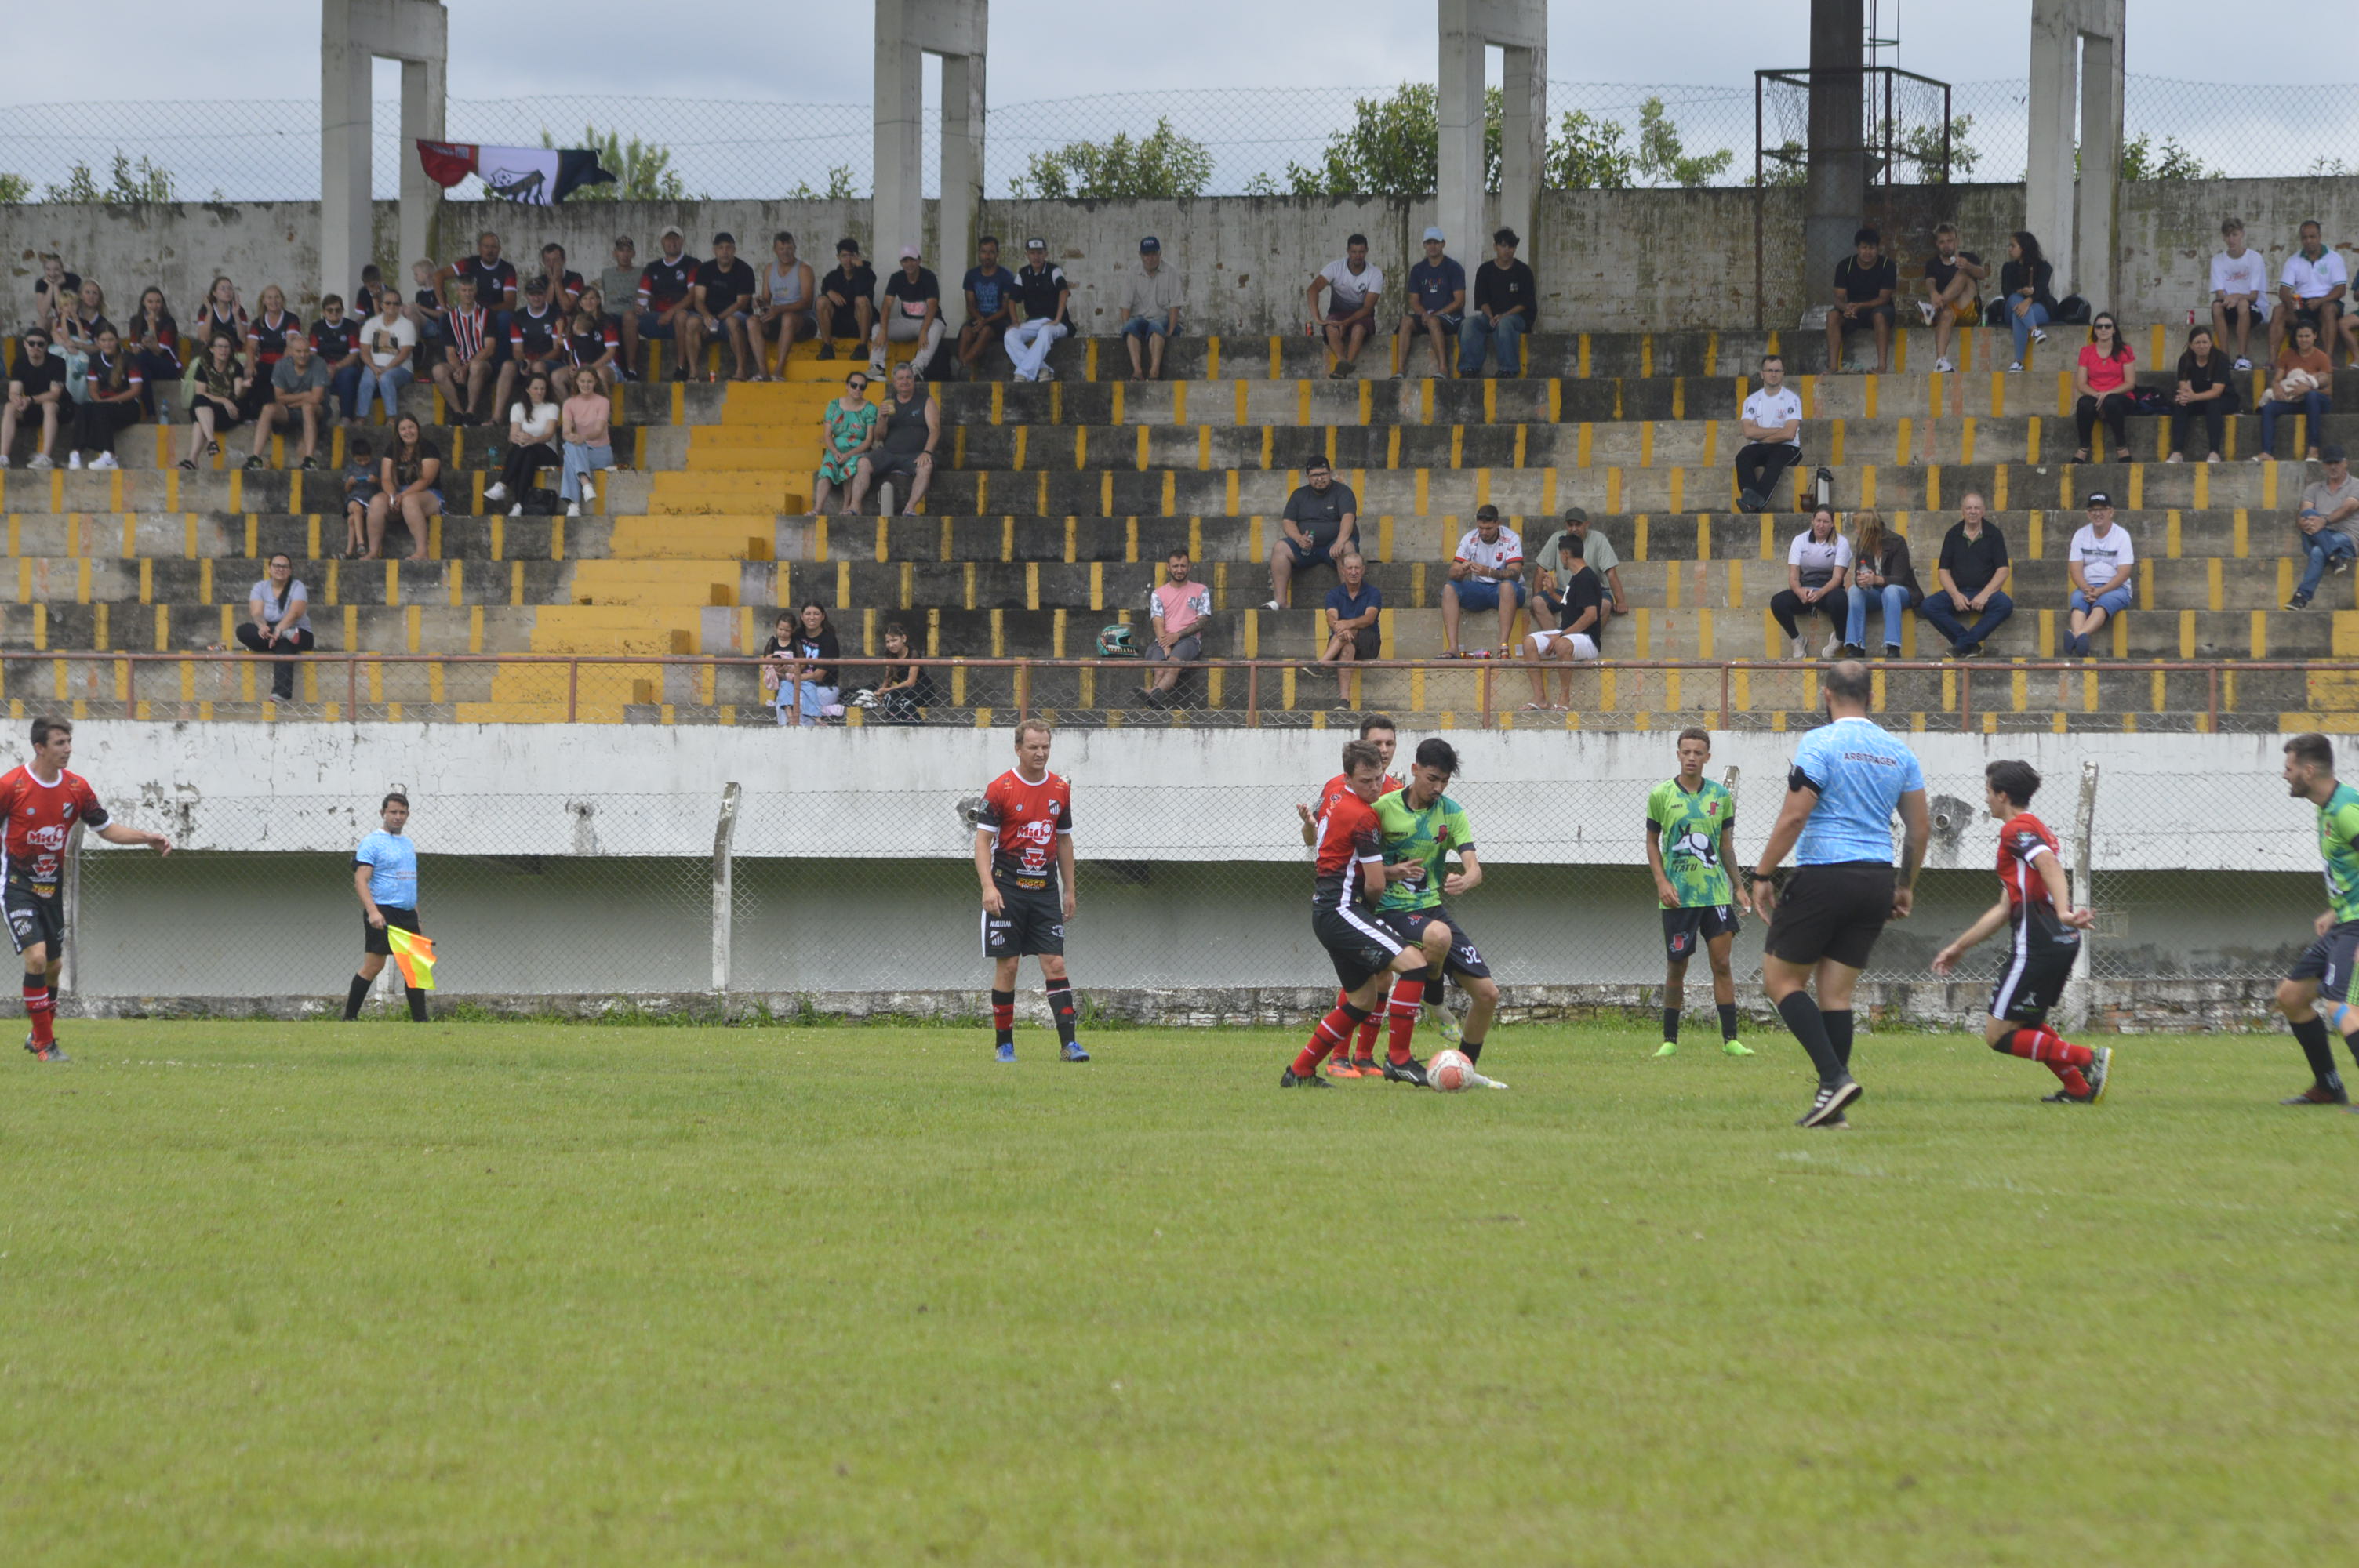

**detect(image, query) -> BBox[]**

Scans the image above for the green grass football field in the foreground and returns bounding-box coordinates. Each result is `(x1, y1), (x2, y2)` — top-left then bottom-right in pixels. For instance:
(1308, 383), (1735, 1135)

(0, 1023), (2359, 1568)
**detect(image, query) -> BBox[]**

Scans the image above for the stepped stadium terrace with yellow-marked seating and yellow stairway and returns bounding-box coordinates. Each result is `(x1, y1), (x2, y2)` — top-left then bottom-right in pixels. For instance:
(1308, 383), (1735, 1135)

(0, 328), (2359, 731)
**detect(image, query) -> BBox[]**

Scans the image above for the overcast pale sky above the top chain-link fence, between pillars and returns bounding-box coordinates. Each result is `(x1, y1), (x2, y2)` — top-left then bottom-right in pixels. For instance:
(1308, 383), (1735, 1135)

(7, 0), (2359, 108)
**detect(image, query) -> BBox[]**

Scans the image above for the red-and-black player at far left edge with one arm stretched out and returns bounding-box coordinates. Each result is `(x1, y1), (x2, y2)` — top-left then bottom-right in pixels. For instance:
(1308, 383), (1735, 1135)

(0, 719), (173, 1061)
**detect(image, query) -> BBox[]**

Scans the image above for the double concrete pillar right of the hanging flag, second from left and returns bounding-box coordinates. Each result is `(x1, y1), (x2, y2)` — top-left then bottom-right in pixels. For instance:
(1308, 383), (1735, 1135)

(873, 0), (990, 328)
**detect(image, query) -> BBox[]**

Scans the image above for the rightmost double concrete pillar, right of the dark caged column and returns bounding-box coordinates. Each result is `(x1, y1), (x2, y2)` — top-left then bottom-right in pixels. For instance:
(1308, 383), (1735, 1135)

(2024, 0), (2128, 309)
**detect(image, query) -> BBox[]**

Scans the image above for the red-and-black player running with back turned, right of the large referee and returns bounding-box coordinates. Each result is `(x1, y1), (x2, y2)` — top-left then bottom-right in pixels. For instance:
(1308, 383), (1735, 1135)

(1932, 761), (2114, 1106)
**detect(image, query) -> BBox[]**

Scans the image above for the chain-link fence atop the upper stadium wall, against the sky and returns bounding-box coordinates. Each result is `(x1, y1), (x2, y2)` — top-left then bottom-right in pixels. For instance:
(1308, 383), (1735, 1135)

(0, 75), (2359, 201)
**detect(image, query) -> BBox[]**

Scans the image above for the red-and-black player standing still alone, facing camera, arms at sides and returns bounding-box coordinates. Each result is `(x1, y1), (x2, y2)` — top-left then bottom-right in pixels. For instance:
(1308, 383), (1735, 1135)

(974, 719), (1090, 1061)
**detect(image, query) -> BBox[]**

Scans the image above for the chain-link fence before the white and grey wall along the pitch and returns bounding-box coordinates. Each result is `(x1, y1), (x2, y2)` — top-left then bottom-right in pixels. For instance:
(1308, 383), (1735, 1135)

(71, 757), (2319, 1011)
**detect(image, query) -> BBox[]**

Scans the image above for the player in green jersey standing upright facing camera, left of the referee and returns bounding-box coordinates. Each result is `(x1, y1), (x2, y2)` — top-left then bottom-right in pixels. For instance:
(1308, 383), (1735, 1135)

(1647, 728), (1753, 1056)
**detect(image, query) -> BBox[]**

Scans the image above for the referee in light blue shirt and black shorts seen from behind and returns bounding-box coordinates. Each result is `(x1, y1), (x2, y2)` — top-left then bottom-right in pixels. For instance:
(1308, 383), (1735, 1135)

(1753, 660), (1932, 1127)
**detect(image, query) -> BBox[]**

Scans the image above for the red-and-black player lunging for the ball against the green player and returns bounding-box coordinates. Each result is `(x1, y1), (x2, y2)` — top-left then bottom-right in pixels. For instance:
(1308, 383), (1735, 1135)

(1278, 740), (1448, 1089)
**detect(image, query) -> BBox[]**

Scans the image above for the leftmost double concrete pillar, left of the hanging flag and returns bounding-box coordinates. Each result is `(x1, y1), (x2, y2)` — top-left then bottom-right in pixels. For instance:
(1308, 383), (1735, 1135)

(318, 0), (451, 299)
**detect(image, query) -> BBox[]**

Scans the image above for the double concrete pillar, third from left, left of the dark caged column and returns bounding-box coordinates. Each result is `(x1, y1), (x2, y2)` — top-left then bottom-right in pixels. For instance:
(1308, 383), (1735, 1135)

(1434, 0), (1547, 276)
